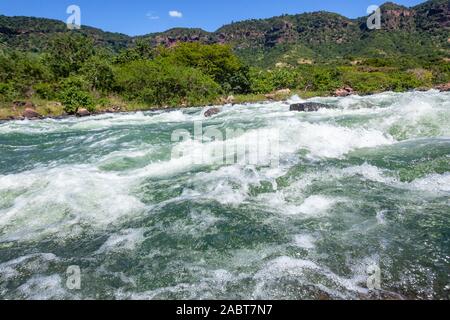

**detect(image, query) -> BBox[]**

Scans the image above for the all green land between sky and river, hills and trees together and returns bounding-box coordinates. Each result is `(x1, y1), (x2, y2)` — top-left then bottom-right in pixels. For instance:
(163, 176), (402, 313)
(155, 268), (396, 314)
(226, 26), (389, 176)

(0, 0), (450, 118)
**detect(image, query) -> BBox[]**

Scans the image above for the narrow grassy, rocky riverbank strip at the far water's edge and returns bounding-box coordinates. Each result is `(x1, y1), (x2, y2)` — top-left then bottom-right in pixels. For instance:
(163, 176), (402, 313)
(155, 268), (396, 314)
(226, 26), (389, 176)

(0, 83), (450, 121)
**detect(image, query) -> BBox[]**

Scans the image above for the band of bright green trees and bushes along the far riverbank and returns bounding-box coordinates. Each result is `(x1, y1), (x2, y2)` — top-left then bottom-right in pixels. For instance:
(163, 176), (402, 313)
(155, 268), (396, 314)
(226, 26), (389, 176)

(0, 32), (450, 114)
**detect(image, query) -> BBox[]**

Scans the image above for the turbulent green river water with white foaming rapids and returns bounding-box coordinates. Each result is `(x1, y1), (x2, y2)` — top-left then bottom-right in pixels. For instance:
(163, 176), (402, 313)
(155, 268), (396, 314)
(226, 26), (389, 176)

(0, 91), (450, 299)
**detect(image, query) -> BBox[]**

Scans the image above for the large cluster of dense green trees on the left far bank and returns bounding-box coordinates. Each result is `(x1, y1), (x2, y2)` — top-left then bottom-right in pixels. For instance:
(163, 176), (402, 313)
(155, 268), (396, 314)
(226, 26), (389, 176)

(0, 36), (251, 114)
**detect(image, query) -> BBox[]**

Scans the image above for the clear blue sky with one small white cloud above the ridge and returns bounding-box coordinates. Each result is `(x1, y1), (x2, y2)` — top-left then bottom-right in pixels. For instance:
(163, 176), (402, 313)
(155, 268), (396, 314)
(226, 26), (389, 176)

(0, 0), (424, 35)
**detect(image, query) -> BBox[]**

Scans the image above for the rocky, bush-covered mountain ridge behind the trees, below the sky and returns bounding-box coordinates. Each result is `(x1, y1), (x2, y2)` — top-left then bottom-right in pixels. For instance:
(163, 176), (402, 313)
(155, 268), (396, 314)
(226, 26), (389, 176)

(0, 0), (450, 66)
